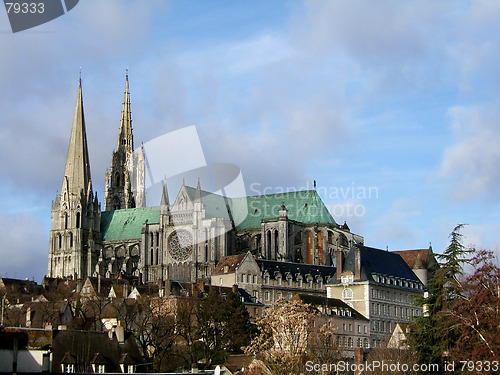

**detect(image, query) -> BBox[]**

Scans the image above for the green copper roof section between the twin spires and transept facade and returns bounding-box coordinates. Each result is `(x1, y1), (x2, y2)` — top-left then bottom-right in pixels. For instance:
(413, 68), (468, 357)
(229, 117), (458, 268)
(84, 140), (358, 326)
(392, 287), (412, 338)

(101, 207), (160, 241)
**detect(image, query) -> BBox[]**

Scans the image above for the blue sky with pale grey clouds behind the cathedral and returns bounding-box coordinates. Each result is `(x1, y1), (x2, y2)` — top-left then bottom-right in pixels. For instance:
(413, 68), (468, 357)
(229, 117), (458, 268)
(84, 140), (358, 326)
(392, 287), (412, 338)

(0, 0), (500, 281)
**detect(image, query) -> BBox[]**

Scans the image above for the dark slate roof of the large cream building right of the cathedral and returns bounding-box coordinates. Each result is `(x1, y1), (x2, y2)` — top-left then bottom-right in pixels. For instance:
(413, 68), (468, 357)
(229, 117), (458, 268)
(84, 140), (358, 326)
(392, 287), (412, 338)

(330, 244), (421, 284)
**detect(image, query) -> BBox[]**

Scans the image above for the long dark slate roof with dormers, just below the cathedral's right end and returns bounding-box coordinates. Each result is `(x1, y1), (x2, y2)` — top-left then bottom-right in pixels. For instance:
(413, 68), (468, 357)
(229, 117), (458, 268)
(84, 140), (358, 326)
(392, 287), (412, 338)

(255, 259), (336, 280)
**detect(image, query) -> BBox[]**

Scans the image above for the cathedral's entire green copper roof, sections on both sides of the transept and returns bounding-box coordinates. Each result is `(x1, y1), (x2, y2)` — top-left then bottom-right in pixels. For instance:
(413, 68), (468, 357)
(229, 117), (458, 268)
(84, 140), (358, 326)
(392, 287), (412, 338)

(101, 186), (336, 241)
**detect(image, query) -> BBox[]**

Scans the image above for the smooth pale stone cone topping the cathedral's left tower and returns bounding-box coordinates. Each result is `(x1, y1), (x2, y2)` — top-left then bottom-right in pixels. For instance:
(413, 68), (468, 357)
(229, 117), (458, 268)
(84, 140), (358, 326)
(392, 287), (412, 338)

(61, 78), (92, 199)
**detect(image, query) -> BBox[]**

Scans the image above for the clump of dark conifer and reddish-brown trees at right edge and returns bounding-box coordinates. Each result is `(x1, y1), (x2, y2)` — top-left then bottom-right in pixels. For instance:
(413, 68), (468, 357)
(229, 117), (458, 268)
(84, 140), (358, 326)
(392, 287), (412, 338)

(410, 224), (500, 369)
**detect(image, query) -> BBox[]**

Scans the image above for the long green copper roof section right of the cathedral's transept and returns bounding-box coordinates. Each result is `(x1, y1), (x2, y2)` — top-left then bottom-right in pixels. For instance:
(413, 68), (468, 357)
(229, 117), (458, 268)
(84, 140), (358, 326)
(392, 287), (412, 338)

(231, 190), (335, 229)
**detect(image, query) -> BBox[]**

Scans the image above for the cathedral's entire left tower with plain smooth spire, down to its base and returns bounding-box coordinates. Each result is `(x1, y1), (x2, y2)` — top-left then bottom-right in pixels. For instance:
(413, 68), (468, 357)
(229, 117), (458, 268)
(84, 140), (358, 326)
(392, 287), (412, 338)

(47, 78), (101, 279)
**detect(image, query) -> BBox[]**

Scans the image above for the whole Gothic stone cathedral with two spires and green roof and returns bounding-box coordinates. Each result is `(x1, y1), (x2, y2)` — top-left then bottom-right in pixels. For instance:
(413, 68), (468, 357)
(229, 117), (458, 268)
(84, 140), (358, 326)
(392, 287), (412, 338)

(47, 75), (363, 282)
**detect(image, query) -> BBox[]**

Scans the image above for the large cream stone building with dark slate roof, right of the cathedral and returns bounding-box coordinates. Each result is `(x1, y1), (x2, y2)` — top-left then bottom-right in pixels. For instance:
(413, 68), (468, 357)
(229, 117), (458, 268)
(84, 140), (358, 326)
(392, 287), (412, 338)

(327, 245), (424, 347)
